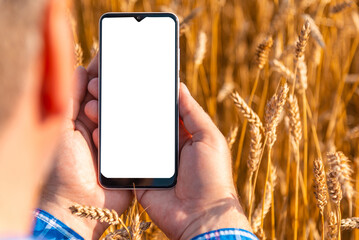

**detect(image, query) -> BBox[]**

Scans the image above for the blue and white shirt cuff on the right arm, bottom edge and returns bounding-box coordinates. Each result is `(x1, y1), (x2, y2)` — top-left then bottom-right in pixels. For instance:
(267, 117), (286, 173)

(192, 228), (258, 240)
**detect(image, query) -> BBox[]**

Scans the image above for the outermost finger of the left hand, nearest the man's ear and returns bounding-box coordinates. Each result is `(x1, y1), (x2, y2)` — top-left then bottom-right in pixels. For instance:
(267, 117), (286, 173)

(69, 66), (88, 120)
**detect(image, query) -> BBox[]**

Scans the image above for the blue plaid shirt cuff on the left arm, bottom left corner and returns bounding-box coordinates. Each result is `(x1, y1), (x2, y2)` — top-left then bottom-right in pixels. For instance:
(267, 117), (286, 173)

(33, 209), (84, 240)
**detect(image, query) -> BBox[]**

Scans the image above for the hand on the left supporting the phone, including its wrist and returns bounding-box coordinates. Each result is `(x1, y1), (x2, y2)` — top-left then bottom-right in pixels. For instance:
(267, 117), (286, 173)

(39, 56), (133, 239)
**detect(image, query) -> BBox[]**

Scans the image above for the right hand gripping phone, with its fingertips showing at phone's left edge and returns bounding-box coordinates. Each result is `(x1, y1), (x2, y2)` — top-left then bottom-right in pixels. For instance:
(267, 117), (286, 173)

(87, 82), (251, 239)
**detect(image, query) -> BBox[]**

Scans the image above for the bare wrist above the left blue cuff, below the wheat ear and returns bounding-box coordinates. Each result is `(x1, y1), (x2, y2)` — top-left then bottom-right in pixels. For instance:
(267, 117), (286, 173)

(39, 194), (108, 240)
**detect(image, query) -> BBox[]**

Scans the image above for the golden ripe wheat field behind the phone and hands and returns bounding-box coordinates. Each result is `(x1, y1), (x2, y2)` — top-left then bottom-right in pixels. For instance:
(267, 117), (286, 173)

(69, 0), (359, 239)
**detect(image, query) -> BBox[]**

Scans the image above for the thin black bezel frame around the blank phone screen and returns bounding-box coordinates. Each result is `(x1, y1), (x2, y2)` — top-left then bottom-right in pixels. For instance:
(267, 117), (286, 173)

(98, 12), (179, 189)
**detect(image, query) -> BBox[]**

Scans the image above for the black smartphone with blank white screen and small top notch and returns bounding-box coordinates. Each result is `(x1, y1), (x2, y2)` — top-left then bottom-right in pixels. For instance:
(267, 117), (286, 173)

(98, 13), (179, 189)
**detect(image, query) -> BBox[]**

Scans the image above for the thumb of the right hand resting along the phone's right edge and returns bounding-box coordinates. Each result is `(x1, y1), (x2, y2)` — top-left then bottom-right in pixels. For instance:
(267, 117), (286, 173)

(179, 83), (219, 141)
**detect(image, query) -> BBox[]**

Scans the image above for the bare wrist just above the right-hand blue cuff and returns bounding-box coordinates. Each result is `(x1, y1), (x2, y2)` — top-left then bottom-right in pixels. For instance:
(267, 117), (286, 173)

(180, 198), (252, 240)
